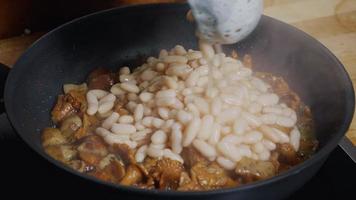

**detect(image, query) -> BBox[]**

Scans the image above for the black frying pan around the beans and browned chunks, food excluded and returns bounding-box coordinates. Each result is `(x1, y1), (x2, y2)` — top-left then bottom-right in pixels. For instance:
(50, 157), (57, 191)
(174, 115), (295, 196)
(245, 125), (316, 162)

(0, 4), (354, 199)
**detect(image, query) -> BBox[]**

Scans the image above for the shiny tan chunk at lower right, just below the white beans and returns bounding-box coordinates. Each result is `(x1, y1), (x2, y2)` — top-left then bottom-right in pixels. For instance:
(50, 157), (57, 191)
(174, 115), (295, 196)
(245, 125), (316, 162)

(235, 157), (277, 183)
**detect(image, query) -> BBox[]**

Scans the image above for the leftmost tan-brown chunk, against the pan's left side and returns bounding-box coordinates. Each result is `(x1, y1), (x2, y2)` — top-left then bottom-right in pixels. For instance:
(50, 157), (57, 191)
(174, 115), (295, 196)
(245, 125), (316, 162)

(42, 128), (67, 147)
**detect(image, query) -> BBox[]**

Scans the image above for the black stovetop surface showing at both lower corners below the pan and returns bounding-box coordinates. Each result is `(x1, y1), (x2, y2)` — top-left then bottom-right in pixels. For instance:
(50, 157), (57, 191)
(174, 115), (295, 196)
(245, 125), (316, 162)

(0, 114), (356, 200)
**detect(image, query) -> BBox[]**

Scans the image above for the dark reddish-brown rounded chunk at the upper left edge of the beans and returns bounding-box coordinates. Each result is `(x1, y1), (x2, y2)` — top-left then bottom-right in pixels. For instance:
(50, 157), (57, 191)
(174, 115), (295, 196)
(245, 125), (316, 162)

(87, 68), (115, 90)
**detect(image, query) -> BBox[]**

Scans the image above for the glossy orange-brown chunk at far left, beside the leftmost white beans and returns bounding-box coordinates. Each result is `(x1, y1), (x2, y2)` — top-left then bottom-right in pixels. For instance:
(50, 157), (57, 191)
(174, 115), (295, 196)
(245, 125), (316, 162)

(51, 90), (87, 124)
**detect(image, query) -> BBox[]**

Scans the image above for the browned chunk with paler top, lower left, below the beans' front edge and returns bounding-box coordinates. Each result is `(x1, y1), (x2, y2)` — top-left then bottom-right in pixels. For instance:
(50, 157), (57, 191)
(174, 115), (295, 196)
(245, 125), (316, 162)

(92, 154), (125, 183)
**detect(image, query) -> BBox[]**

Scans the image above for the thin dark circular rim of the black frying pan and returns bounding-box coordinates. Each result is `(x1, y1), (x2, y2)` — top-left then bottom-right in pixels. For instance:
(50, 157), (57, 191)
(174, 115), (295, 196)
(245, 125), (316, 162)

(4, 3), (355, 196)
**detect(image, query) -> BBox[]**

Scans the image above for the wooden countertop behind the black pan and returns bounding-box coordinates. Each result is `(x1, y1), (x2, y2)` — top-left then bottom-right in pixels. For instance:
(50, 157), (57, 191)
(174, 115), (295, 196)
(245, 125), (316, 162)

(0, 0), (356, 145)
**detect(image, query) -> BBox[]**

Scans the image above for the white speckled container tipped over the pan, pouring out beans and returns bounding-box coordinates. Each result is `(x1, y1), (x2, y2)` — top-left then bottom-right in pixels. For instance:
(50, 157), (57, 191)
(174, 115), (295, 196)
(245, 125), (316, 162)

(188, 0), (263, 44)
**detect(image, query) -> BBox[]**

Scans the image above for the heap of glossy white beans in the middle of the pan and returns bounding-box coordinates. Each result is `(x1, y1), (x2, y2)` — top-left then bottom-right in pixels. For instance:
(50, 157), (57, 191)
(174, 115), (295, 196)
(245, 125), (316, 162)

(87, 44), (300, 170)
